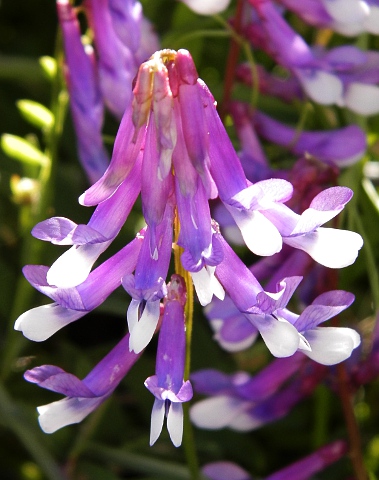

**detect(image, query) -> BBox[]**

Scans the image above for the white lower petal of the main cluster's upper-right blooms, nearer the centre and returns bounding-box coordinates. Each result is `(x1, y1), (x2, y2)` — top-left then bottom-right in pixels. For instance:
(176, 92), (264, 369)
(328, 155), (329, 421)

(227, 206), (282, 256)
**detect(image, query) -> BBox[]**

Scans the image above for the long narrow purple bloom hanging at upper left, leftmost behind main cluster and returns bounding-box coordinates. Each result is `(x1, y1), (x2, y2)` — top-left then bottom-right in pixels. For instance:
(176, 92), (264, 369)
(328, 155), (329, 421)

(57, 0), (109, 183)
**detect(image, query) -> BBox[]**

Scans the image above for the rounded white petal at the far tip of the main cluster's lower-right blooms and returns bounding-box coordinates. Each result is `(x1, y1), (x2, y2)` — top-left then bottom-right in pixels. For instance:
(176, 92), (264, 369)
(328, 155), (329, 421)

(303, 327), (361, 365)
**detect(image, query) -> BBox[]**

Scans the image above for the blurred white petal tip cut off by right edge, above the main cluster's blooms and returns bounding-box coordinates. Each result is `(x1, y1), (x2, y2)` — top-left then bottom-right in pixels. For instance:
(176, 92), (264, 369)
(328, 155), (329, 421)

(344, 82), (379, 116)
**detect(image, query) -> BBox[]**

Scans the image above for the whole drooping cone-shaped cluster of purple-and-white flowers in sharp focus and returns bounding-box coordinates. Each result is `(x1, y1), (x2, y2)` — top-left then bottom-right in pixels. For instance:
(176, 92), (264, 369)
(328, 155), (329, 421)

(15, 46), (362, 446)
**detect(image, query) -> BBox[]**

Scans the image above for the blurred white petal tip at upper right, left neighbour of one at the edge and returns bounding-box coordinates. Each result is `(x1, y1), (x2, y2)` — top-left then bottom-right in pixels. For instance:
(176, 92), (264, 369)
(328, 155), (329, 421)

(294, 68), (343, 105)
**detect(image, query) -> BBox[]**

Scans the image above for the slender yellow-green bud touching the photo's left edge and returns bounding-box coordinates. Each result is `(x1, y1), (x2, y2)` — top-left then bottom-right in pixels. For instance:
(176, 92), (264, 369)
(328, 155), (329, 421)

(1, 133), (49, 167)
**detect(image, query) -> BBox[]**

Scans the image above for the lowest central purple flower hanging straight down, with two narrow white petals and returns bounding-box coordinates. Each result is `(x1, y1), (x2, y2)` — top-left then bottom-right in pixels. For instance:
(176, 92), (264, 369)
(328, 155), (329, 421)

(145, 275), (192, 447)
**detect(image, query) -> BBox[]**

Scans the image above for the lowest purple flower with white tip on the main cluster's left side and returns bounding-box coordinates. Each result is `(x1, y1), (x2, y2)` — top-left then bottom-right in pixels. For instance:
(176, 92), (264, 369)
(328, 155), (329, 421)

(24, 334), (140, 433)
